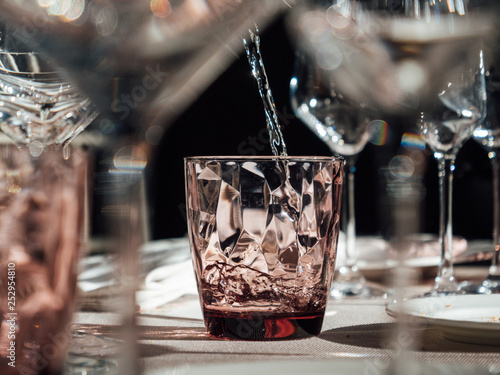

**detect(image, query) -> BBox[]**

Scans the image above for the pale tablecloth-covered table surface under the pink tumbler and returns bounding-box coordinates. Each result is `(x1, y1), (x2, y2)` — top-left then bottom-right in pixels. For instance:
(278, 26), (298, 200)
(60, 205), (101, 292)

(70, 267), (500, 375)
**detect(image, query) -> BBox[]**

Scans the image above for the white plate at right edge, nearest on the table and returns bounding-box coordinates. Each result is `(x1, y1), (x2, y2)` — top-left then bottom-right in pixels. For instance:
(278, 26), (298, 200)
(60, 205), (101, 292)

(387, 294), (500, 345)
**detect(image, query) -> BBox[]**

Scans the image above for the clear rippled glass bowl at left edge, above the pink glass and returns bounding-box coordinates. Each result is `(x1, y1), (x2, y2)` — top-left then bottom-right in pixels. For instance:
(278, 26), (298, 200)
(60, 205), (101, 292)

(0, 51), (98, 147)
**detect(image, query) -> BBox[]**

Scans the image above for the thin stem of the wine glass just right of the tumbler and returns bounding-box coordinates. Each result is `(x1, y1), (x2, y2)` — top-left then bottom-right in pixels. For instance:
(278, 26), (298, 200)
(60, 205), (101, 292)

(344, 158), (358, 267)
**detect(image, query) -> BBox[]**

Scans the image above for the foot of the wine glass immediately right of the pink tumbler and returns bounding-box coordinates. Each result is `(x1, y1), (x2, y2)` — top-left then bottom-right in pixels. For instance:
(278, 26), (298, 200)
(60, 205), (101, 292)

(330, 266), (371, 299)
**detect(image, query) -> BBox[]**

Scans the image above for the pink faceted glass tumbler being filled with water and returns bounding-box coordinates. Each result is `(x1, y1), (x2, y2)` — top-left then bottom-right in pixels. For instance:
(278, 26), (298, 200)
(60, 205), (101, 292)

(185, 156), (344, 340)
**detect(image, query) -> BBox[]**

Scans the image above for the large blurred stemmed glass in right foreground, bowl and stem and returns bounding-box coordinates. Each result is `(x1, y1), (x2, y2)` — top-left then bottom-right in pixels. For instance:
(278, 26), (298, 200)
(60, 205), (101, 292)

(289, 0), (499, 373)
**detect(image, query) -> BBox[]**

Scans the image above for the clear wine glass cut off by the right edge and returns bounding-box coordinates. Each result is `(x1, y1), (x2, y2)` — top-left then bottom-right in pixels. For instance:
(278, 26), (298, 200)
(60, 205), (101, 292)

(460, 76), (500, 294)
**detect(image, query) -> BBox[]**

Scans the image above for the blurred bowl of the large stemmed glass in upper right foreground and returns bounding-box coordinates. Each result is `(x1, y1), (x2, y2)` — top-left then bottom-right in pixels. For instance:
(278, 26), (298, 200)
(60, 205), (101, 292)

(290, 0), (498, 114)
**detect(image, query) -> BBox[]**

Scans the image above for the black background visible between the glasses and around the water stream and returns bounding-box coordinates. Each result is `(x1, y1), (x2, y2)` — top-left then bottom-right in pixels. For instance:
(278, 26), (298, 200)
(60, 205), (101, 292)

(148, 14), (492, 239)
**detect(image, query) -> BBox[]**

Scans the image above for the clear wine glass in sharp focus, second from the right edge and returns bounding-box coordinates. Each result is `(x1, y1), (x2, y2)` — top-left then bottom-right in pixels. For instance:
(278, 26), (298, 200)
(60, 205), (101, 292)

(420, 51), (487, 296)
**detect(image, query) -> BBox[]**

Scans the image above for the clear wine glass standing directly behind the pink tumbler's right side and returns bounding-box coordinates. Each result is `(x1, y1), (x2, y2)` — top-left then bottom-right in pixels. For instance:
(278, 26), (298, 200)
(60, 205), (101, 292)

(290, 53), (380, 298)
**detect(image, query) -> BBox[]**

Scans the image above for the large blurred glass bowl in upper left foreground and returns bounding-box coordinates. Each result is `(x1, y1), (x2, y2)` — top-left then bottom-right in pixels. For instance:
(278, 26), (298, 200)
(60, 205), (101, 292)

(0, 0), (294, 138)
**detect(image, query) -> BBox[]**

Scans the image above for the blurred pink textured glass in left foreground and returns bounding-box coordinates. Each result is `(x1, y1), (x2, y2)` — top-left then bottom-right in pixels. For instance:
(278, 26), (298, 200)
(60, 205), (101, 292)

(0, 145), (87, 375)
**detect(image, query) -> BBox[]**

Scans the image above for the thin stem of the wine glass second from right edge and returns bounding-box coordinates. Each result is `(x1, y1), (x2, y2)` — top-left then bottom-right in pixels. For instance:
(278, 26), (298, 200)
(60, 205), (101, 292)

(438, 155), (455, 282)
